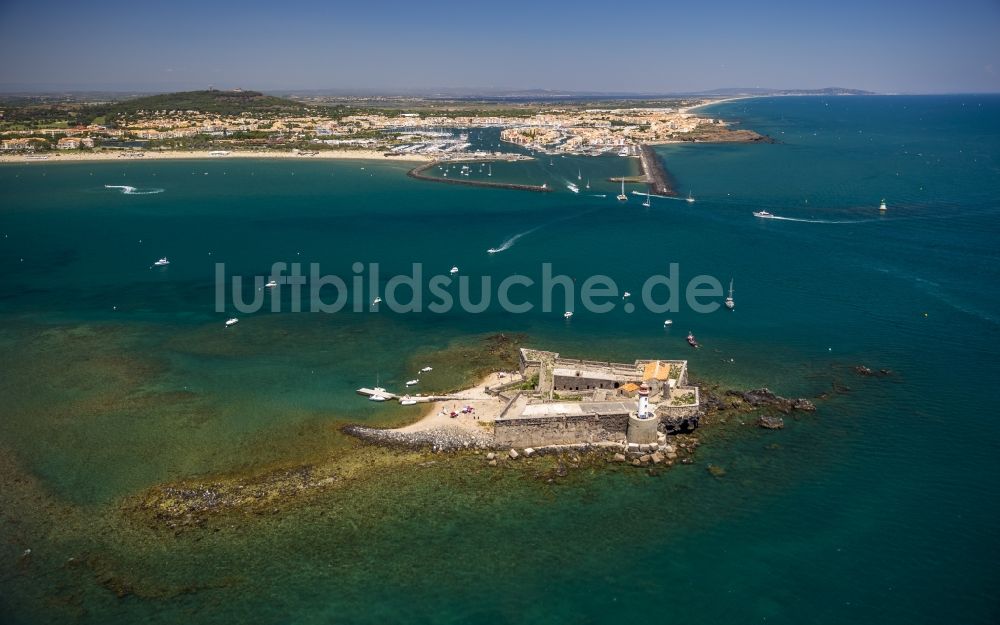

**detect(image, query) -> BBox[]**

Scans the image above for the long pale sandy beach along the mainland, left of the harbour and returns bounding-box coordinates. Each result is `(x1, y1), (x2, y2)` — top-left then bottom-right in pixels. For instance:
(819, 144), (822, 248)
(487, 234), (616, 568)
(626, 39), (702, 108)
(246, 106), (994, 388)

(0, 150), (434, 165)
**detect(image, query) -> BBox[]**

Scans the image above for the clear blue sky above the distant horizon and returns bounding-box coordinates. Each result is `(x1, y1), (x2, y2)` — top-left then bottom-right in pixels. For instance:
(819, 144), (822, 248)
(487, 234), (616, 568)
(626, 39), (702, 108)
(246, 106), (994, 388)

(0, 0), (1000, 93)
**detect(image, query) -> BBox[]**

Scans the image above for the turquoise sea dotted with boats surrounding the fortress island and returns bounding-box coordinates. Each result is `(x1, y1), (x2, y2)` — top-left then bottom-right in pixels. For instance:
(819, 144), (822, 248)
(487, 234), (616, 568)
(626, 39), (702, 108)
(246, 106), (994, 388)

(0, 95), (1000, 625)
